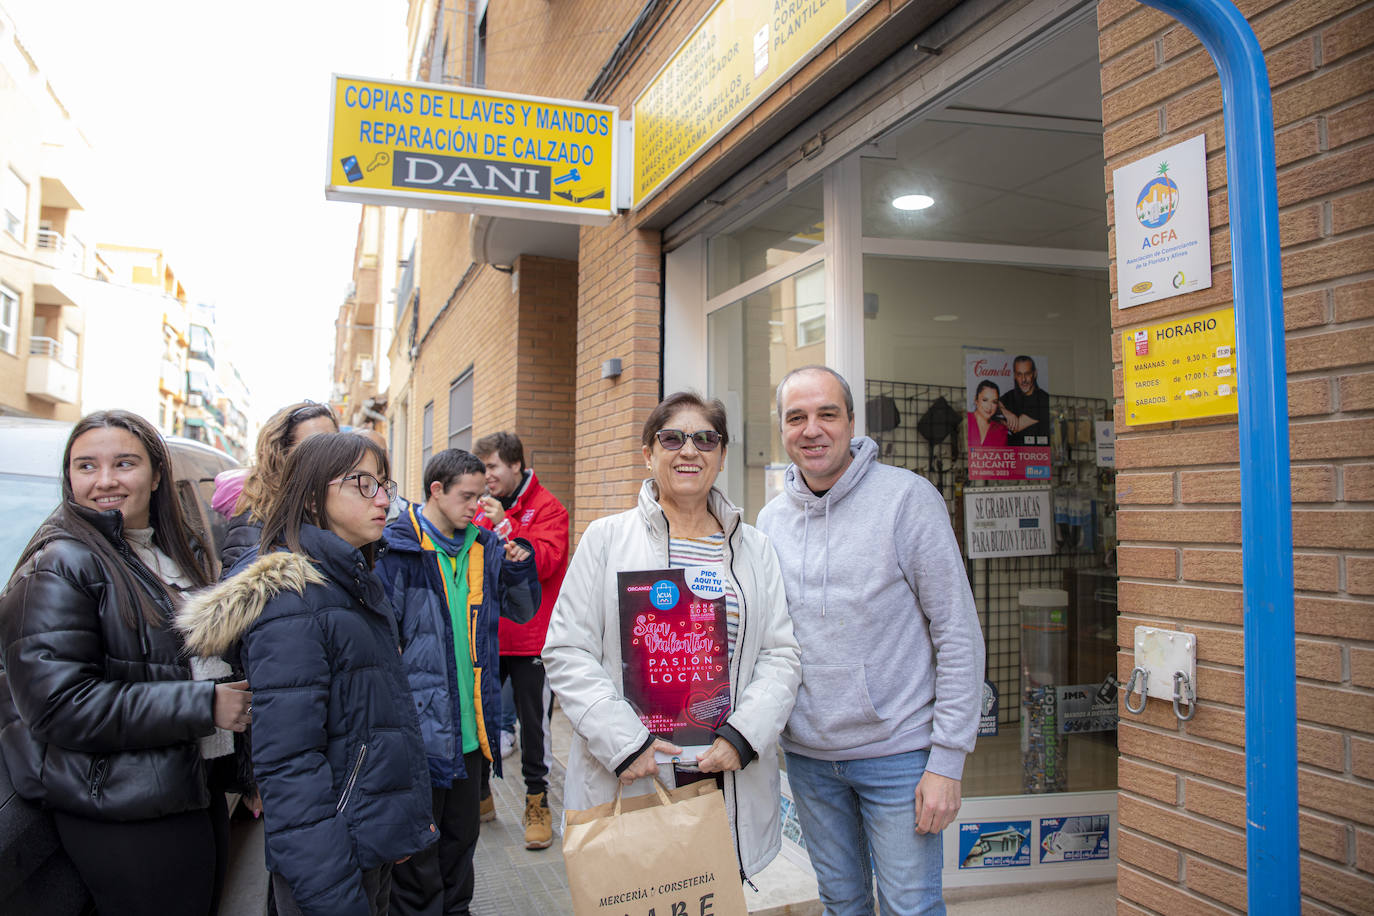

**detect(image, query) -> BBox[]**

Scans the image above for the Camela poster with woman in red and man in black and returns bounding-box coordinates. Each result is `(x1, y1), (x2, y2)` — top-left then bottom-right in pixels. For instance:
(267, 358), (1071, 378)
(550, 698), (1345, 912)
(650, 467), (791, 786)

(965, 350), (1050, 481)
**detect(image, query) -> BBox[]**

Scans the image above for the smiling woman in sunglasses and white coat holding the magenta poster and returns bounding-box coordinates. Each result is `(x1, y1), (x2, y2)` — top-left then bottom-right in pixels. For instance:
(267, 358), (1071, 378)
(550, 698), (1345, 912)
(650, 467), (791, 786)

(544, 391), (801, 878)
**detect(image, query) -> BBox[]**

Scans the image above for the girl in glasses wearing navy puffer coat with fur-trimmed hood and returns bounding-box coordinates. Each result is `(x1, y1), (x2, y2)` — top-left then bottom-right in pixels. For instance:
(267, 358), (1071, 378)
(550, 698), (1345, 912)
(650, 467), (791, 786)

(177, 433), (434, 916)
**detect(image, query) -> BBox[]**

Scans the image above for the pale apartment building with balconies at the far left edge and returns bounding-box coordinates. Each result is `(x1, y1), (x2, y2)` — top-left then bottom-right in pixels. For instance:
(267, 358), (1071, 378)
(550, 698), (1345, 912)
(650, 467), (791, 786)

(0, 10), (93, 420)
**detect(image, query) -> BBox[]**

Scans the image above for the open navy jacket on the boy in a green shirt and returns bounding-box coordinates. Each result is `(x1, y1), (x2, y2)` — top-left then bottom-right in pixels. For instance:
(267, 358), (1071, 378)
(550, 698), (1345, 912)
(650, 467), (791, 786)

(376, 505), (540, 787)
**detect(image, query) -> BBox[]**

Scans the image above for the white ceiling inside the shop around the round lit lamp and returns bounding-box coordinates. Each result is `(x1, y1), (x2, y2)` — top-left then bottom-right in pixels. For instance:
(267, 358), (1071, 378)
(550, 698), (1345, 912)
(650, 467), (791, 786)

(863, 18), (1107, 251)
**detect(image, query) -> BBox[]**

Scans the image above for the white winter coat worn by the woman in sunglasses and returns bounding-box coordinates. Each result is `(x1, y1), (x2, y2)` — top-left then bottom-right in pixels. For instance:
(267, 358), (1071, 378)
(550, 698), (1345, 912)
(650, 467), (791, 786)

(544, 481), (801, 875)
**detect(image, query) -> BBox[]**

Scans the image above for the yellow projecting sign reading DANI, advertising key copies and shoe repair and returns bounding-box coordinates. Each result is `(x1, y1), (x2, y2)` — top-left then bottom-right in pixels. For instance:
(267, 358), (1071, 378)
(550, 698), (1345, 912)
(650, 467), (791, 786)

(324, 74), (617, 222)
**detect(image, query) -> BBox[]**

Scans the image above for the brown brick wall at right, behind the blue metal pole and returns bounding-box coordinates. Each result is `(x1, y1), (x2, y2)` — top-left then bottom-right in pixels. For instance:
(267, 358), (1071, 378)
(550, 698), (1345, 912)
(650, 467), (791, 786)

(1098, 0), (1374, 915)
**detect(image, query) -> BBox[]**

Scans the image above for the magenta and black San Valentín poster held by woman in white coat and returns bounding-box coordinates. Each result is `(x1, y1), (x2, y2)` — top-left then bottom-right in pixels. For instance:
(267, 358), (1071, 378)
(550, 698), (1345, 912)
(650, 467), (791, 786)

(617, 566), (730, 758)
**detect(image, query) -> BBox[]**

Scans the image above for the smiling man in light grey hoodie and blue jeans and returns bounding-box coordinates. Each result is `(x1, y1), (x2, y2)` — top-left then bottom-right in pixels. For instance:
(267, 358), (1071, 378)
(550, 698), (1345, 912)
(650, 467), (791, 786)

(758, 365), (984, 916)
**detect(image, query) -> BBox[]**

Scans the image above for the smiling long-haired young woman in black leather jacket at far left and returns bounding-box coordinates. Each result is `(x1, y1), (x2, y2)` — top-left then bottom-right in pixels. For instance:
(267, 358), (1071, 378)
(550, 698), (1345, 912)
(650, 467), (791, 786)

(0, 411), (251, 916)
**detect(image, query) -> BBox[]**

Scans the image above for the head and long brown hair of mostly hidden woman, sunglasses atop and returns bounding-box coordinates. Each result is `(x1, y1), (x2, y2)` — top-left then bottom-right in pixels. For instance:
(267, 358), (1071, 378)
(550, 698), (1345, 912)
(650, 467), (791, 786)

(212, 401), (339, 575)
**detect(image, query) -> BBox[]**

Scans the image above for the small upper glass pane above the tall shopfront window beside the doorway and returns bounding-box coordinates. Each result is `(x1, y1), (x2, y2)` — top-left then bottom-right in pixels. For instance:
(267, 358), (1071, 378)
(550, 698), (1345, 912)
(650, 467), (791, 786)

(706, 180), (826, 298)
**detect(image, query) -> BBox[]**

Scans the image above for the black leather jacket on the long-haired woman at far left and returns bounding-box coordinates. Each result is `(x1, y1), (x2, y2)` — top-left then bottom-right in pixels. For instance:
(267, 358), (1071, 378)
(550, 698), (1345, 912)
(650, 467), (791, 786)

(0, 504), (214, 820)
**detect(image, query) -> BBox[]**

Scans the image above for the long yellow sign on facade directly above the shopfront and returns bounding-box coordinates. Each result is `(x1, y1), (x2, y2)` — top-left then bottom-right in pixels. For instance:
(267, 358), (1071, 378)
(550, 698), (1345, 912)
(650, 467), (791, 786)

(635, 0), (872, 206)
